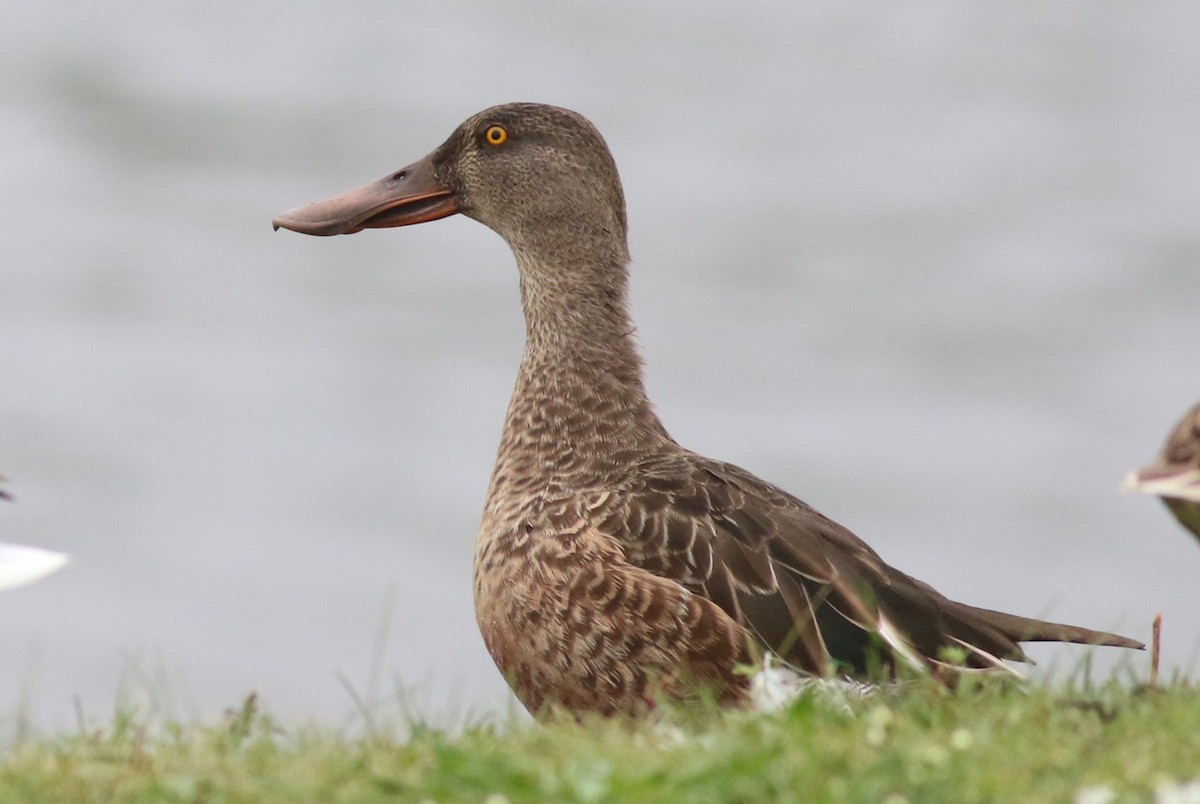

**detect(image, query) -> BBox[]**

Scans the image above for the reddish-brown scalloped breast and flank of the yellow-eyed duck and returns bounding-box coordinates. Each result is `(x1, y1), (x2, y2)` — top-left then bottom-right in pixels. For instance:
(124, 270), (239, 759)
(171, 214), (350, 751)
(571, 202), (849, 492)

(476, 503), (752, 714)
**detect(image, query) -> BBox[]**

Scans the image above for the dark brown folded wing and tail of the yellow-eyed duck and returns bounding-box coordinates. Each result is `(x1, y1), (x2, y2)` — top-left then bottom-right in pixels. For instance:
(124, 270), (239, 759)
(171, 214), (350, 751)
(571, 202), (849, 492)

(588, 452), (1141, 674)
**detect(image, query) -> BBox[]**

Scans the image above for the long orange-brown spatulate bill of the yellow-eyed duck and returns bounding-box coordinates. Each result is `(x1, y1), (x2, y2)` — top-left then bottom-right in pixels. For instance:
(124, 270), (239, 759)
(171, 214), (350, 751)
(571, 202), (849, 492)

(271, 157), (458, 236)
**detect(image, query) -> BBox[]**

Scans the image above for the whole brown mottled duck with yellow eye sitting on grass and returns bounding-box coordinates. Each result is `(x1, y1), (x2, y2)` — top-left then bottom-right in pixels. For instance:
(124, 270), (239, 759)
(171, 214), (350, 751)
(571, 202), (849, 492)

(272, 103), (1144, 716)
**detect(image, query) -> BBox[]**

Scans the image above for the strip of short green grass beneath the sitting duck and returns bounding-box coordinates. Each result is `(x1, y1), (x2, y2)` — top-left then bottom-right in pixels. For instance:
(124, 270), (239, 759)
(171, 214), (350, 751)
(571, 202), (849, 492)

(0, 679), (1200, 804)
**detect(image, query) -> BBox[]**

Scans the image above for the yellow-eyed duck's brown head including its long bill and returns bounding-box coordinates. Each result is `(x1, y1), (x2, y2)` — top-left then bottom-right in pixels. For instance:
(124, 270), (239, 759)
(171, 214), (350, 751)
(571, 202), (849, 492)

(274, 103), (625, 247)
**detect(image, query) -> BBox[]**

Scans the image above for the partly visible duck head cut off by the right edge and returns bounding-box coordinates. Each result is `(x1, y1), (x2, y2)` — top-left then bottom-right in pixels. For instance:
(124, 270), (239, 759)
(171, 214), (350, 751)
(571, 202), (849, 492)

(1124, 404), (1200, 539)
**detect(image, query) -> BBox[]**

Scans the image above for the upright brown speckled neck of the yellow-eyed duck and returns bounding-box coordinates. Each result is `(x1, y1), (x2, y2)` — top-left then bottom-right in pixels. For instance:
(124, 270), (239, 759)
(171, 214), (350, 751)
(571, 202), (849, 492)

(492, 240), (670, 493)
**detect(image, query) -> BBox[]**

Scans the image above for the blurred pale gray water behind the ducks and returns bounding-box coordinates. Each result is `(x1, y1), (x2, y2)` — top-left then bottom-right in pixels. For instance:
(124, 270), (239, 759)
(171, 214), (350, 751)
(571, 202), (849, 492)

(0, 0), (1200, 730)
